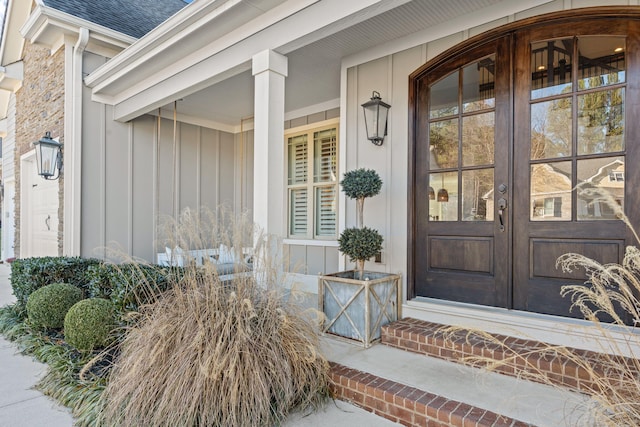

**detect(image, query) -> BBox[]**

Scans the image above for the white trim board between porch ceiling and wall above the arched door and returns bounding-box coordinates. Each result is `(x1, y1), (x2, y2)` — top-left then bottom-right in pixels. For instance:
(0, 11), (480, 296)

(342, 0), (555, 68)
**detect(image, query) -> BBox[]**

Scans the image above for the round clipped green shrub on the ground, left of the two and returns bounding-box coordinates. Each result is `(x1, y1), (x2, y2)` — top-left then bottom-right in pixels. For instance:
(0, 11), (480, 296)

(27, 283), (83, 329)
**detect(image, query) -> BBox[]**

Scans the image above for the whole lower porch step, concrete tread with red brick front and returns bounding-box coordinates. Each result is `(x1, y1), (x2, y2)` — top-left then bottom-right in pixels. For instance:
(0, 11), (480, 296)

(322, 336), (591, 427)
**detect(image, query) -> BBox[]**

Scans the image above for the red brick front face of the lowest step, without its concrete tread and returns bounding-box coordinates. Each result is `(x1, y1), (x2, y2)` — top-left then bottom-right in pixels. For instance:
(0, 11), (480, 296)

(331, 363), (532, 427)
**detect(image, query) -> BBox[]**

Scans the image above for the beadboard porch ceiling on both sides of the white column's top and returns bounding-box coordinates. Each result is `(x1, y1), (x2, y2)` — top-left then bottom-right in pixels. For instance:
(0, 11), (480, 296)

(168, 0), (524, 124)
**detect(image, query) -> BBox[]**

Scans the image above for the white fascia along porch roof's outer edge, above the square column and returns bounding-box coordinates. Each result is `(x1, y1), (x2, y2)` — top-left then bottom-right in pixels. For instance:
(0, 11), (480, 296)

(97, 0), (409, 121)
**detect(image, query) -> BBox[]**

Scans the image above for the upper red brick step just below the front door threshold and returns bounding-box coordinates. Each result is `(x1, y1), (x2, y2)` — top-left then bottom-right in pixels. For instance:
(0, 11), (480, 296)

(381, 318), (638, 394)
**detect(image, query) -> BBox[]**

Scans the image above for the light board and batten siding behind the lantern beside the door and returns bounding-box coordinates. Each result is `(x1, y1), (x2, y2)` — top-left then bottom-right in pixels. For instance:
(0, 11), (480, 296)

(340, 46), (424, 282)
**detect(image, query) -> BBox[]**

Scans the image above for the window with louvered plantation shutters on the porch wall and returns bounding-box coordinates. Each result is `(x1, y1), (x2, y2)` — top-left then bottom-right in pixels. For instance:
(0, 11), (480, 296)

(287, 123), (338, 239)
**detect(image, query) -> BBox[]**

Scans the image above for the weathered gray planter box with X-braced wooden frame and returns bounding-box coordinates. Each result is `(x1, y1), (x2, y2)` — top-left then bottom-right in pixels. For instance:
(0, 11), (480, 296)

(318, 270), (402, 348)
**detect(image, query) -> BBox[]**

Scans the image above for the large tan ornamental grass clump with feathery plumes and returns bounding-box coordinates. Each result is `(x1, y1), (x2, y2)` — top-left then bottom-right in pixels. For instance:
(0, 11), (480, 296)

(99, 206), (329, 426)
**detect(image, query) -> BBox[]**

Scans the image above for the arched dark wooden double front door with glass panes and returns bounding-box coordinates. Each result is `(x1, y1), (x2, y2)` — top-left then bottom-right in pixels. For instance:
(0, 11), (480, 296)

(410, 15), (640, 316)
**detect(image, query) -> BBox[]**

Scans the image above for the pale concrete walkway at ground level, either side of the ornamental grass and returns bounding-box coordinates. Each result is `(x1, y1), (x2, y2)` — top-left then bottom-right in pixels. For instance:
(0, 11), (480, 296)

(0, 264), (398, 427)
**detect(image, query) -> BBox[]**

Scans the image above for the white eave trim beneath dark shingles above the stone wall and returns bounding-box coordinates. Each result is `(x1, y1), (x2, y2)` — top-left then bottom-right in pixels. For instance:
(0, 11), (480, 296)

(20, 6), (137, 50)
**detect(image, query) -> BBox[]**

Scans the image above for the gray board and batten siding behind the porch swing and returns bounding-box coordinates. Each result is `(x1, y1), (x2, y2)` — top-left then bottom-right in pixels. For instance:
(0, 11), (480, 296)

(81, 55), (253, 261)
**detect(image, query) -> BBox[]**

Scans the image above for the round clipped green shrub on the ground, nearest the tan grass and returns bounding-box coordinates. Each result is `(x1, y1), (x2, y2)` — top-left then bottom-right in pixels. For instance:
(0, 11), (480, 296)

(64, 298), (115, 351)
